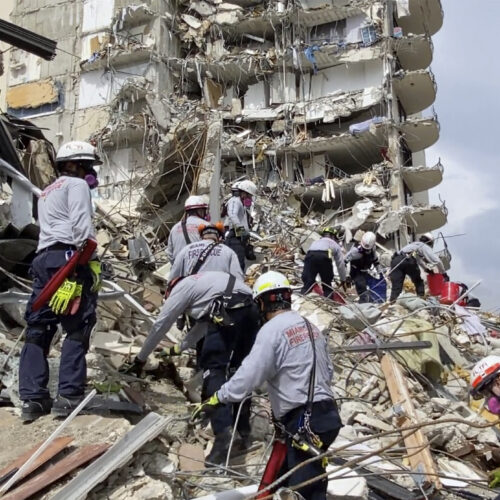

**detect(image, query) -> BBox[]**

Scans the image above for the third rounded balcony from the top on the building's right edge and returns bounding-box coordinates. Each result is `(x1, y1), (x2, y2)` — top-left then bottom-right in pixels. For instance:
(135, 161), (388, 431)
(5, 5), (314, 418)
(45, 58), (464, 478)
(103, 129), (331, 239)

(393, 70), (437, 115)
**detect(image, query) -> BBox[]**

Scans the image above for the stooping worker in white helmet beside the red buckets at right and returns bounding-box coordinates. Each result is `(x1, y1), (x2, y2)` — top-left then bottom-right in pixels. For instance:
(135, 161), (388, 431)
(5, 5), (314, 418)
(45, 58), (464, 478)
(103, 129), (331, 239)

(389, 233), (447, 302)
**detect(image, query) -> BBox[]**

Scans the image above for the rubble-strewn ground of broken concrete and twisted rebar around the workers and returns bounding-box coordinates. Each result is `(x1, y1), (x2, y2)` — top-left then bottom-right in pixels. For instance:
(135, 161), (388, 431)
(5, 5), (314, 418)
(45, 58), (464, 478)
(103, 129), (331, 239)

(0, 184), (500, 499)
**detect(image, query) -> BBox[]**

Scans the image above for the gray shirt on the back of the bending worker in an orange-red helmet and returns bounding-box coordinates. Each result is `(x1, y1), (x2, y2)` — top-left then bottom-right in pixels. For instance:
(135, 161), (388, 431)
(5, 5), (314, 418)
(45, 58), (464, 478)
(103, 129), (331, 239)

(168, 240), (245, 281)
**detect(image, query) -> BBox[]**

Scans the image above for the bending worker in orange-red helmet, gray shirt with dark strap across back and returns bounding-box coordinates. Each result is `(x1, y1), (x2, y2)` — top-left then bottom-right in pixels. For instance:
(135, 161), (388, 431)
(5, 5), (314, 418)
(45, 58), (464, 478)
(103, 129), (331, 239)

(168, 222), (245, 281)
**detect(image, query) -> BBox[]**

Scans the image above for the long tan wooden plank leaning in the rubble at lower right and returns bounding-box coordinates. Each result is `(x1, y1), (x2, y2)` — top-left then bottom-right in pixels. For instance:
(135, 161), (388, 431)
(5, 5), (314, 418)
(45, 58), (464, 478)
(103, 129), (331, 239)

(380, 354), (442, 490)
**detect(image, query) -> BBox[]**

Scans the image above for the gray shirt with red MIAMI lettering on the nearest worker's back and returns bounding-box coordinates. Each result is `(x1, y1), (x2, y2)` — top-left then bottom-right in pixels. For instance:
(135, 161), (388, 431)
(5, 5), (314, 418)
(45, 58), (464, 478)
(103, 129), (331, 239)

(217, 311), (333, 418)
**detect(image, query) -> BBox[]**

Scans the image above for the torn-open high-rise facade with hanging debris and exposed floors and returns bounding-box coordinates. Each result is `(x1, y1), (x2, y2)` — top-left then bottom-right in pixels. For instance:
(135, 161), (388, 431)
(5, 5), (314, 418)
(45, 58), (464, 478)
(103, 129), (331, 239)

(7, 0), (446, 247)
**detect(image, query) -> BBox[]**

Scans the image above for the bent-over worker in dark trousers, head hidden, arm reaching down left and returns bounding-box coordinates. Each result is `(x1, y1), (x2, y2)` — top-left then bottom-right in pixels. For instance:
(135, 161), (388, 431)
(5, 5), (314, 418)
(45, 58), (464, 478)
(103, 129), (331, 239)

(121, 271), (260, 466)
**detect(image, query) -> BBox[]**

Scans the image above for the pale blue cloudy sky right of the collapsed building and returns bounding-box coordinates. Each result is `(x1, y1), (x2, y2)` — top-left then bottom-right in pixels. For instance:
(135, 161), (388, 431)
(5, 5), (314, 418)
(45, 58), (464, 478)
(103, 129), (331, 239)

(426, 0), (500, 312)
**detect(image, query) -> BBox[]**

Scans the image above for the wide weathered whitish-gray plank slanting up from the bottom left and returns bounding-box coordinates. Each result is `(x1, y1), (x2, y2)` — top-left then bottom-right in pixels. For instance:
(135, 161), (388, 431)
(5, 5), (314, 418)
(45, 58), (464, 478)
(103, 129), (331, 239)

(52, 412), (168, 500)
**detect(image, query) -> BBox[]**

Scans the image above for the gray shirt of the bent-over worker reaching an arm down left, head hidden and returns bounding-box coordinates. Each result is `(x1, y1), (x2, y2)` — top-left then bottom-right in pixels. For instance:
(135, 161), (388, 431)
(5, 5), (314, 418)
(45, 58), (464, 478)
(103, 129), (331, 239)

(137, 271), (252, 361)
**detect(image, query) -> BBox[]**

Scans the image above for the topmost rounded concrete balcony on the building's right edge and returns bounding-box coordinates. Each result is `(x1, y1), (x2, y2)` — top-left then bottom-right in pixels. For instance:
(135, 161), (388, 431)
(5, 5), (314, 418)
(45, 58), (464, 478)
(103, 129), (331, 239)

(396, 0), (444, 36)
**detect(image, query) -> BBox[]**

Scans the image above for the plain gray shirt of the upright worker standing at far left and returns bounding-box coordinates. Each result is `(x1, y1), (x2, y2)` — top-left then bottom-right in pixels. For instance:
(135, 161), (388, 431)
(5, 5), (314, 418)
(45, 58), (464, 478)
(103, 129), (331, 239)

(37, 175), (95, 251)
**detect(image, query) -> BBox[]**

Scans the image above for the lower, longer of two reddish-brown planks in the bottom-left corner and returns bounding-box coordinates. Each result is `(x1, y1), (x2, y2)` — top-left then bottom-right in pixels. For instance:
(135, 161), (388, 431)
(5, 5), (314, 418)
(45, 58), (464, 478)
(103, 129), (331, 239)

(3, 443), (109, 500)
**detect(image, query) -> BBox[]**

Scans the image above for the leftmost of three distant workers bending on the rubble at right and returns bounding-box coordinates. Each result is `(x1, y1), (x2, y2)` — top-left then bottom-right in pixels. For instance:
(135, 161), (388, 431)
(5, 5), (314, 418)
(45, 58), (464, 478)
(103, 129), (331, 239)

(301, 227), (347, 297)
